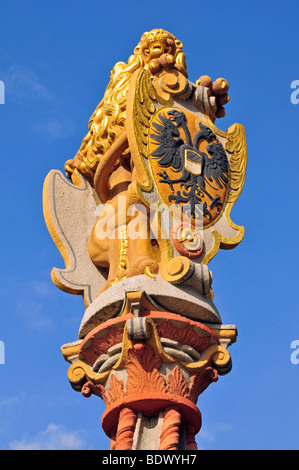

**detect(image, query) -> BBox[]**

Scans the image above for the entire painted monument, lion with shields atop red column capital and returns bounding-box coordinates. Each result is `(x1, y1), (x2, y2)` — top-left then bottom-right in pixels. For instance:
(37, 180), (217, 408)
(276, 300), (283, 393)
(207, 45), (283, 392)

(43, 29), (247, 450)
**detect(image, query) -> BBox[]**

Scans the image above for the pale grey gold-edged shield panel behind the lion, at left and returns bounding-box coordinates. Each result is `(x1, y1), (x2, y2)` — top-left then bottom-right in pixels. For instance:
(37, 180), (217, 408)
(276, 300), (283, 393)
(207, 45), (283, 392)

(43, 170), (106, 306)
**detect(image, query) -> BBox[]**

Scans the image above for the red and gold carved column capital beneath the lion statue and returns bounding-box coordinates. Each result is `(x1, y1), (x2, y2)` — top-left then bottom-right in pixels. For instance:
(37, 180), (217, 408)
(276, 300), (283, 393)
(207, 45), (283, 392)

(62, 311), (236, 450)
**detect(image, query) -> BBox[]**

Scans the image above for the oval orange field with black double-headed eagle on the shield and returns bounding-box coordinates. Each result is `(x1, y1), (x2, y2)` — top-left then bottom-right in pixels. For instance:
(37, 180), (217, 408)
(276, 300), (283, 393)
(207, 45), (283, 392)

(148, 107), (228, 227)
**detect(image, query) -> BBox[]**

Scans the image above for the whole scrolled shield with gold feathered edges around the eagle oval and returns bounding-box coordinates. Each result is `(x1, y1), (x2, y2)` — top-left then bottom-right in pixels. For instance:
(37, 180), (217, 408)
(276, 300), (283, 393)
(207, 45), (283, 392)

(127, 66), (247, 277)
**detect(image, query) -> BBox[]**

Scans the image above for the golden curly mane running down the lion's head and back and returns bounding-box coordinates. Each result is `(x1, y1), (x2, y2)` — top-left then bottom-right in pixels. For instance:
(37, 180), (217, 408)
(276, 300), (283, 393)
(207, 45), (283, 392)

(65, 29), (187, 183)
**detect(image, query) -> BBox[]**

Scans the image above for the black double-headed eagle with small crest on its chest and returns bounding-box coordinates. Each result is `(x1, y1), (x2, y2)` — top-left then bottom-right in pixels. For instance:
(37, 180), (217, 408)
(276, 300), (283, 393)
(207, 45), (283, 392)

(150, 109), (228, 221)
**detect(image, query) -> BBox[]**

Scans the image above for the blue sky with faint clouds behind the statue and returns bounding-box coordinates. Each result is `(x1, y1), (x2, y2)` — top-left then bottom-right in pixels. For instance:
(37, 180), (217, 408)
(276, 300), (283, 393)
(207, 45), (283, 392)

(0, 0), (299, 450)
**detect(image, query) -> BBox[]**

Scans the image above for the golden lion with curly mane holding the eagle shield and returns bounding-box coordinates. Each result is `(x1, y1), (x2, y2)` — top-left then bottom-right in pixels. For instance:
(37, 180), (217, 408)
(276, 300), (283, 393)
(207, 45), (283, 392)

(65, 29), (241, 291)
